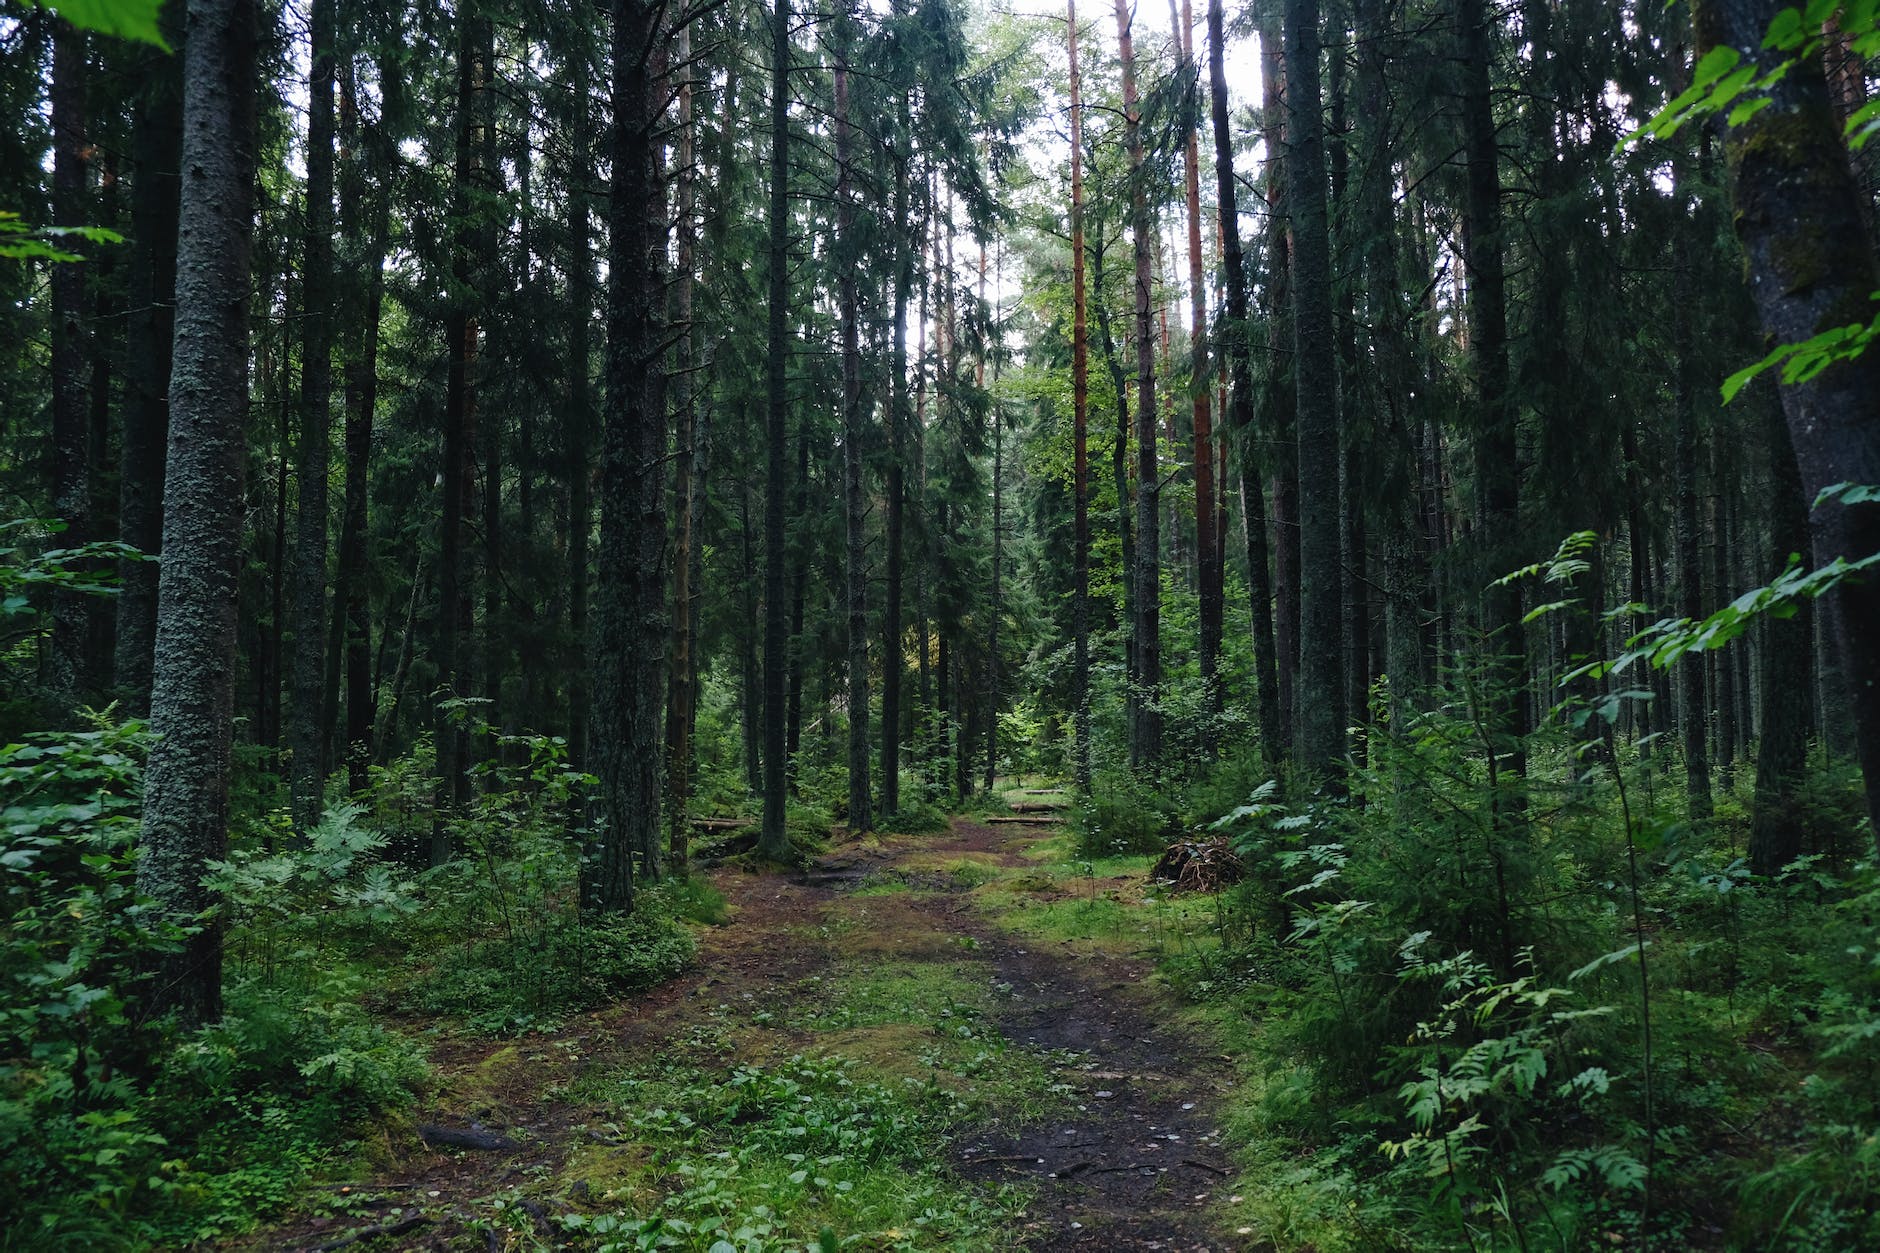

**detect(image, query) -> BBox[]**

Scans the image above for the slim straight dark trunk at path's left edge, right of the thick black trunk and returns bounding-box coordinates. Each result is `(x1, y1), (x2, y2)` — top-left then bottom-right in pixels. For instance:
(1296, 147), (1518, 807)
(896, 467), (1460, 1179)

(758, 0), (790, 860)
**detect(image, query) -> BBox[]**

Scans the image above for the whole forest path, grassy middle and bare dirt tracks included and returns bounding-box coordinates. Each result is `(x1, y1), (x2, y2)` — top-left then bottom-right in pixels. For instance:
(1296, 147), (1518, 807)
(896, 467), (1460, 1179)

(253, 818), (1248, 1251)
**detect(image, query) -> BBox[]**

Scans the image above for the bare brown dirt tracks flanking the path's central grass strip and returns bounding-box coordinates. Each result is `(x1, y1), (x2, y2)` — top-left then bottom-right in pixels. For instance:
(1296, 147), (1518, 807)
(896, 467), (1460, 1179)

(253, 820), (1235, 1253)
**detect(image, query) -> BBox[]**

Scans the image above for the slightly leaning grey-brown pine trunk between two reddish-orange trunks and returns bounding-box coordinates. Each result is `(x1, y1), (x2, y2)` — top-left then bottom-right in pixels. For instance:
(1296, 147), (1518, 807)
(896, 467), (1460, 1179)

(1117, 0), (1162, 769)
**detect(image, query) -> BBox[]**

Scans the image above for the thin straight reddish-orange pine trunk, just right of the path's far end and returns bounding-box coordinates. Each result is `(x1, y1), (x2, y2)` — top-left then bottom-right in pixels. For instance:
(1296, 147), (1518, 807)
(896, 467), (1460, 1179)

(1064, 0), (1097, 796)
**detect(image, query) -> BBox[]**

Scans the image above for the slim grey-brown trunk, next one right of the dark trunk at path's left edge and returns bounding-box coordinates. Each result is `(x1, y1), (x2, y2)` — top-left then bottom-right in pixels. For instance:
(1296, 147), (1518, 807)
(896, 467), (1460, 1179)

(835, 26), (874, 832)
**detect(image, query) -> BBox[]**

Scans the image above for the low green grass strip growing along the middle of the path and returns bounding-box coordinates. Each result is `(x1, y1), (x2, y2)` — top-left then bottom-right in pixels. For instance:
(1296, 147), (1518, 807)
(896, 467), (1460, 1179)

(526, 858), (1077, 1251)
